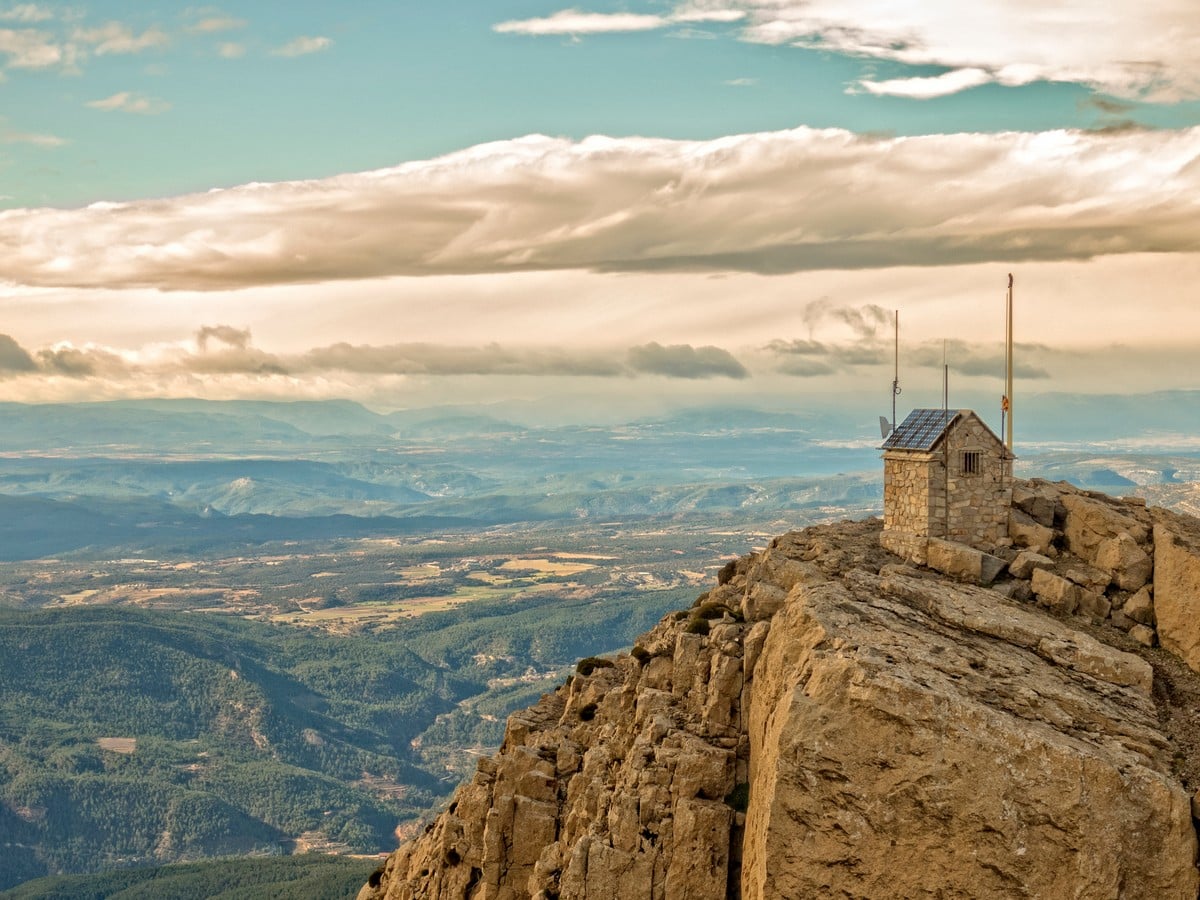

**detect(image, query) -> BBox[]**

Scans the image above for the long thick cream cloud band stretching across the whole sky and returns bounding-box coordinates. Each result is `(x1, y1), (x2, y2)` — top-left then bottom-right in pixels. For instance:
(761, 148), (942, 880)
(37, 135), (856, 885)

(0, 128), (1200, 290)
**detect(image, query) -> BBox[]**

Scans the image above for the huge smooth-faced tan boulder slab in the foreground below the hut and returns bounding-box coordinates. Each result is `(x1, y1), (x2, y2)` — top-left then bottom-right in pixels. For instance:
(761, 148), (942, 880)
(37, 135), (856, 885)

(743, 572), (1196, 899)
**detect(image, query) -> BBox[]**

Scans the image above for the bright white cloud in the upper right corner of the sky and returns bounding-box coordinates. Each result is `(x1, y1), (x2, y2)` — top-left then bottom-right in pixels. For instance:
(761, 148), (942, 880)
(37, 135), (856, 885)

(496, 0), (1200, 102)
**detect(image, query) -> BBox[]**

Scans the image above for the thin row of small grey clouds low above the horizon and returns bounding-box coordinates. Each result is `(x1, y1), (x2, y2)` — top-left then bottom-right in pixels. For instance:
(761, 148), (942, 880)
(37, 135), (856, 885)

(0, 321), (1056, 382)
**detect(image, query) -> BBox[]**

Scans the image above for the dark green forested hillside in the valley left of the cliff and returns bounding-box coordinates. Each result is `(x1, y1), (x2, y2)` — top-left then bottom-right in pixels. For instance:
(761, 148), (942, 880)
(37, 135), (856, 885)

(0, 592), (682, 887)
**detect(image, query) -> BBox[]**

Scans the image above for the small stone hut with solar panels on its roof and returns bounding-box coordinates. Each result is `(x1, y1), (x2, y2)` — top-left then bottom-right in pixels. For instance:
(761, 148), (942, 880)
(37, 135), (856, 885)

(880, 409), (1013, 550)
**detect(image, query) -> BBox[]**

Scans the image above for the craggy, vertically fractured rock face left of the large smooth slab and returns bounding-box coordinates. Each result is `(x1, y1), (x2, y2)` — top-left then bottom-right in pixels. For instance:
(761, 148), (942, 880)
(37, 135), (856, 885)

(361, 595), (748, 900)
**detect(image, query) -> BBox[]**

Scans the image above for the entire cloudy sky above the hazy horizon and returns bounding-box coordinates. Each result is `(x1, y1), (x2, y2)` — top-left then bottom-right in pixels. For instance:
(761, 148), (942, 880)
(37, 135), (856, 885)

(0, 0), (1200, 419)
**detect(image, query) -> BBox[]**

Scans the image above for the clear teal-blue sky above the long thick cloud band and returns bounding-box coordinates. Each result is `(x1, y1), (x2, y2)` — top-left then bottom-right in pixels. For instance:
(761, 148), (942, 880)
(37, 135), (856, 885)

(9, 0), (1200, 206)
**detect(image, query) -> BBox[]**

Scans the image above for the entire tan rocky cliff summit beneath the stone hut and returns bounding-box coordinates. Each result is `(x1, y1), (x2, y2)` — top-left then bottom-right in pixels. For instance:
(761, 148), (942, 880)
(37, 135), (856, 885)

(360, 482), (1200, 900)
